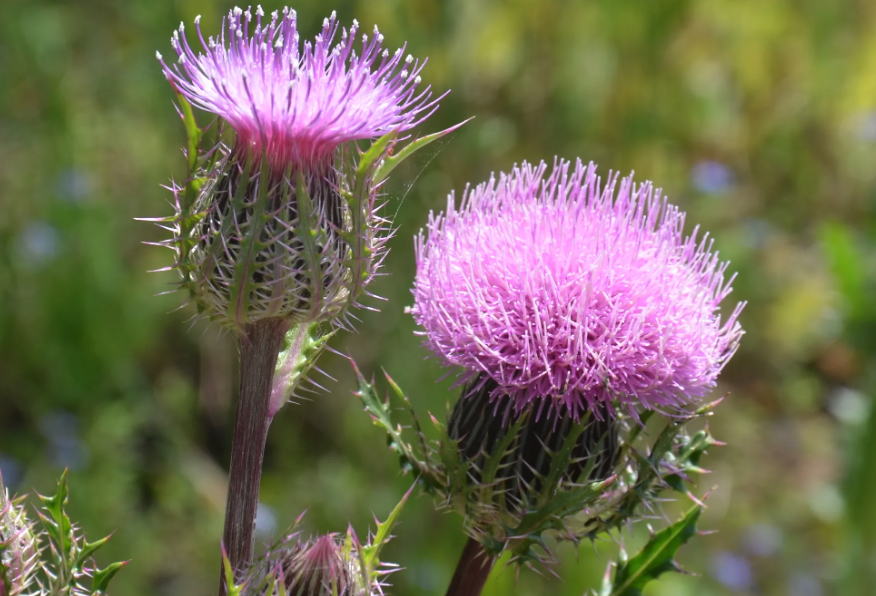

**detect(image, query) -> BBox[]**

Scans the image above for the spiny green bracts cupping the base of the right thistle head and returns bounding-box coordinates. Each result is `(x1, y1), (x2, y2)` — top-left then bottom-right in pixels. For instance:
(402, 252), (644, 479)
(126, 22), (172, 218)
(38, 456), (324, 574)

(356, 370), (719, 566)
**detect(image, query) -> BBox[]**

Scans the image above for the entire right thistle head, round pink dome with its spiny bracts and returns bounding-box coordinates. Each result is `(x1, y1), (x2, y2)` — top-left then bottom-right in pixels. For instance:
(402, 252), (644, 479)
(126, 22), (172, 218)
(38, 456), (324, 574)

(372, 161), (743, 568)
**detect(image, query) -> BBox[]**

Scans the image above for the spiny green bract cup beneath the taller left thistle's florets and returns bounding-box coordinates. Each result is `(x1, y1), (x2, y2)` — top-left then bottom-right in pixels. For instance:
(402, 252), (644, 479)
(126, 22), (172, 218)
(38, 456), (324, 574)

(151, 96), (468, 331)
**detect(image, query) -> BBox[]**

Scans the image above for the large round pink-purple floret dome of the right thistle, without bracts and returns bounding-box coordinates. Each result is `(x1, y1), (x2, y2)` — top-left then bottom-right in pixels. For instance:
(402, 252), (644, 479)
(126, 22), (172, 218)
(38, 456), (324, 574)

(410, 160), (744, 418)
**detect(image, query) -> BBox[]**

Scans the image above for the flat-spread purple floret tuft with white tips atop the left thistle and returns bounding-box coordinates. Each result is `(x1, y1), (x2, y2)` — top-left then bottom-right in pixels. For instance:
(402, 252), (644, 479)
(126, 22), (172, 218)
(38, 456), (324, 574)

(158, 6), (443, 170)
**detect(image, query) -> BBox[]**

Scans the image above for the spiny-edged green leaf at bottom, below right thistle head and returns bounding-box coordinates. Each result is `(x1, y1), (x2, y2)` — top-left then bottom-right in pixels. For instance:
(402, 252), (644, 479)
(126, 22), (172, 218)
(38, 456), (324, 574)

(599, 506), (702, 596)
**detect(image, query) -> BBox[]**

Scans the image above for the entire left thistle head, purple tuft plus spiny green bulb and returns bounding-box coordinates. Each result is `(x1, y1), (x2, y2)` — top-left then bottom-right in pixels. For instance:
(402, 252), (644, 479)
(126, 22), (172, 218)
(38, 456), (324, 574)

(152, 6), (449, 330)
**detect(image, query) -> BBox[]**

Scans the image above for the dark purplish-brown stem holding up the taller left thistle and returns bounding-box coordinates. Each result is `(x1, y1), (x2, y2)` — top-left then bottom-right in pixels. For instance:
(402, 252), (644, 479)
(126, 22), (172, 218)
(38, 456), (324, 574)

(219, 319), (289, 596)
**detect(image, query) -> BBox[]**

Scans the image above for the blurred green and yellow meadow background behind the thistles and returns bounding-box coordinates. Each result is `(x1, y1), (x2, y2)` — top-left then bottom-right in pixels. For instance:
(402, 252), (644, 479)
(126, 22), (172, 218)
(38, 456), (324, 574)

(0, 0), (876, 596)
